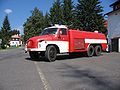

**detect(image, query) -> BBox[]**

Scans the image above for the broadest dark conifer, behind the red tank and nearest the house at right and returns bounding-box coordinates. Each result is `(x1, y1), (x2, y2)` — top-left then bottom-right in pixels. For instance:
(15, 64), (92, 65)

(75, 0), (105, 33)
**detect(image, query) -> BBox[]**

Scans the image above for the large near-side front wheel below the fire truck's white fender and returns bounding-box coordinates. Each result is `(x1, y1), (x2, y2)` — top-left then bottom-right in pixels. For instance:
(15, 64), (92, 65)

(45, 45), (57, 62)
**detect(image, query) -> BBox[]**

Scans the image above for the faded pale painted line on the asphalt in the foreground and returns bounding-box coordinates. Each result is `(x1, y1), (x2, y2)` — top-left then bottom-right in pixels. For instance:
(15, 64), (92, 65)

(34, 62), (51, 90)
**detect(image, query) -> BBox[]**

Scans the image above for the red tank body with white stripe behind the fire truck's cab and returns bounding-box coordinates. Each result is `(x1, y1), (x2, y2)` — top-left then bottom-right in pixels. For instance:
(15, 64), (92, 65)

(69, 30), (107, 52)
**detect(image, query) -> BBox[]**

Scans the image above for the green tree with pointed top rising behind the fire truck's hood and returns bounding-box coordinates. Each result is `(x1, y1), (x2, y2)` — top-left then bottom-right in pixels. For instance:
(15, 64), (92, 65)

(23, 7), (44, 41)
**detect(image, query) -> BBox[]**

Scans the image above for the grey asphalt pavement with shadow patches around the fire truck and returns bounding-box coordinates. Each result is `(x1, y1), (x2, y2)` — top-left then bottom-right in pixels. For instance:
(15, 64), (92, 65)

(0, 48), (120, 90)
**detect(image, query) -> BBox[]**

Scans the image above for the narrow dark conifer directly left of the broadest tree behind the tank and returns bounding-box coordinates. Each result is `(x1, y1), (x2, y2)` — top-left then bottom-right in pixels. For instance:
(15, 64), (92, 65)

(63, 0), (74, 27)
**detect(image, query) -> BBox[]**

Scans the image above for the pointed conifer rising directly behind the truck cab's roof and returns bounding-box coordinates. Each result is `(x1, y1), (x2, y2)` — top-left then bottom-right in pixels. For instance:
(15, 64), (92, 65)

(49, 0), (63, 24)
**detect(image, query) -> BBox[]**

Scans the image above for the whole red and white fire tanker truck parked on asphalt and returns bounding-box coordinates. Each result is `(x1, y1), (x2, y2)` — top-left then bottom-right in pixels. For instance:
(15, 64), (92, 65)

(25, 25), (107, 62)
